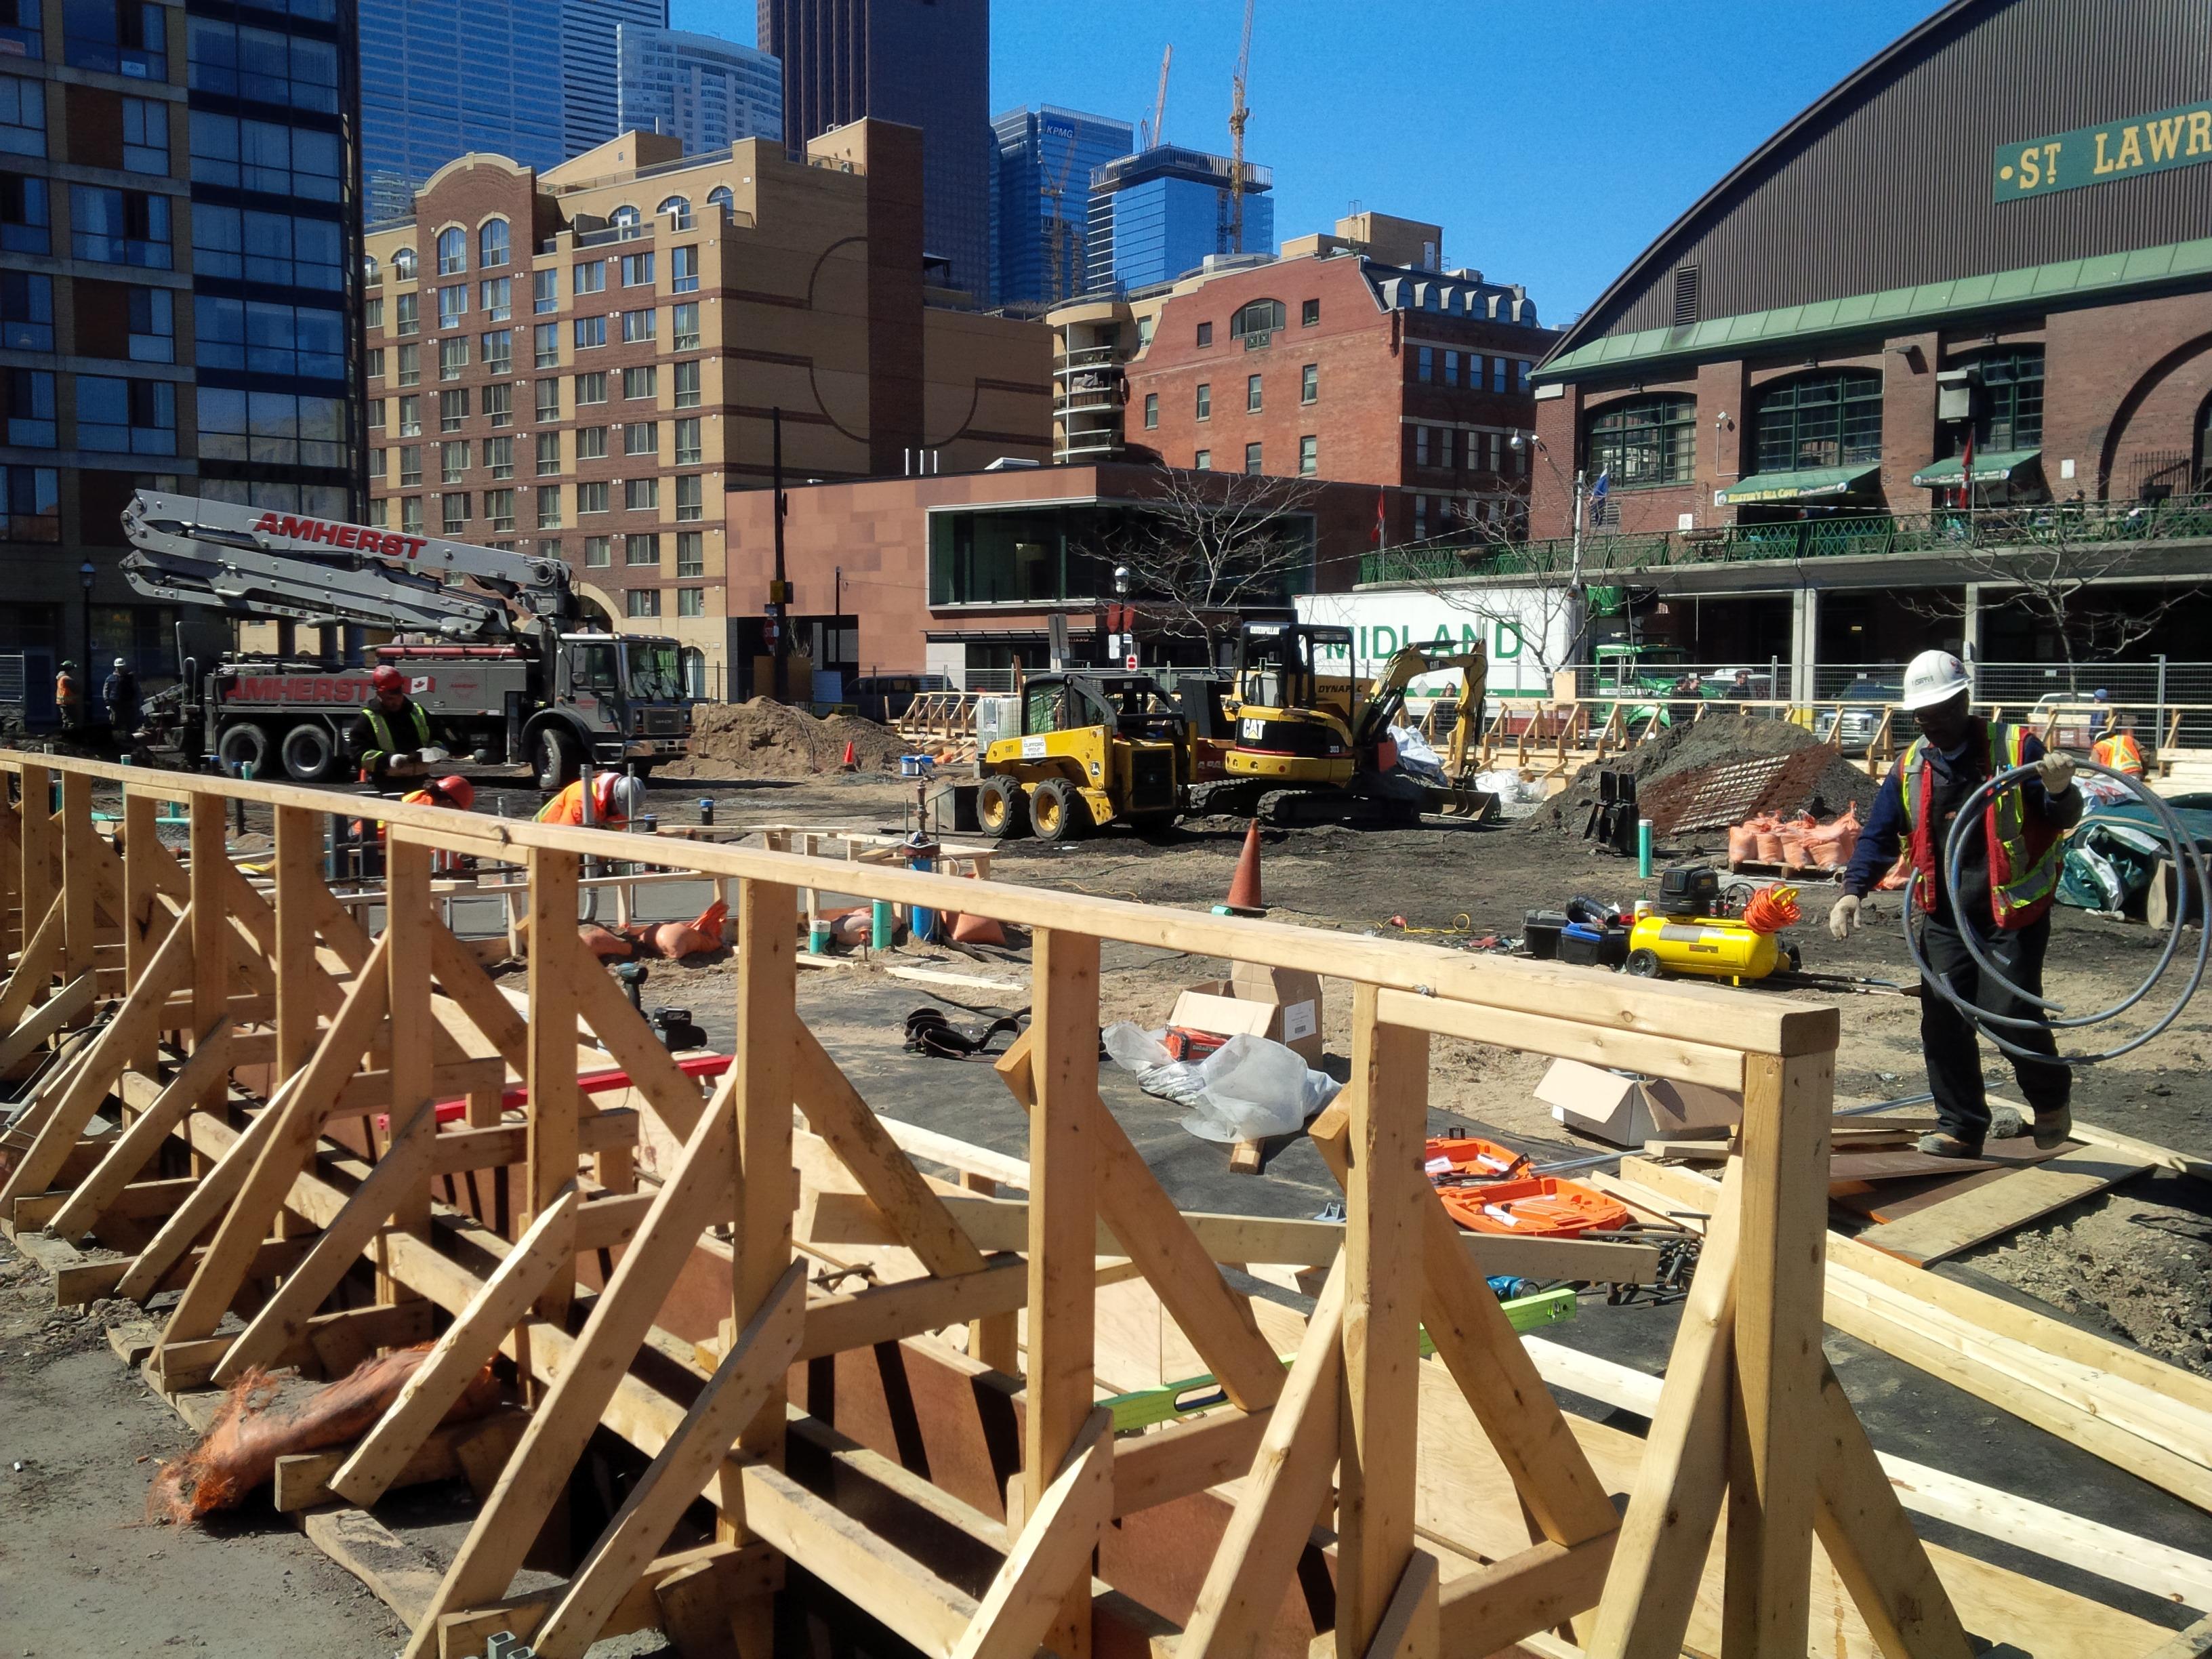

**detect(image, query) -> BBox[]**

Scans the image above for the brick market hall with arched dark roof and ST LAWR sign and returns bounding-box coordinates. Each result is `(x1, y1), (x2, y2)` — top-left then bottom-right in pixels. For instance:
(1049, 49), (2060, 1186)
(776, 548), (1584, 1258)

(1531, 0), (2212, 695)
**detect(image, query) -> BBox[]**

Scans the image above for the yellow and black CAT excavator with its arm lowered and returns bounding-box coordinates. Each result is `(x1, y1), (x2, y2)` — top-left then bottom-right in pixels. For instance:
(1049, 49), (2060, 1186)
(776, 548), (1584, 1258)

(1190, 621), (1498, 827)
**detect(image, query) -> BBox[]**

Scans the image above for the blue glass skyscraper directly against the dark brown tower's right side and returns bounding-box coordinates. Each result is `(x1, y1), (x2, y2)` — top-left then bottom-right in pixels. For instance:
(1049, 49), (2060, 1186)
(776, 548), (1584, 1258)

(991, 104), (1134, 305)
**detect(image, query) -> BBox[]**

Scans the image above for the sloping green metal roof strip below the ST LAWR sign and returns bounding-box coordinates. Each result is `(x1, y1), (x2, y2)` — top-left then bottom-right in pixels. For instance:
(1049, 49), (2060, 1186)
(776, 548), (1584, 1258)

(1535, 237), (2212, 383)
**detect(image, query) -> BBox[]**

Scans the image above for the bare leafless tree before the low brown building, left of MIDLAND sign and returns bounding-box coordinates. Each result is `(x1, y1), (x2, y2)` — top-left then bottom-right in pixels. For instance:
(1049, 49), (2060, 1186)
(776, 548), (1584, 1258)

(1095, 467), (1321, 659)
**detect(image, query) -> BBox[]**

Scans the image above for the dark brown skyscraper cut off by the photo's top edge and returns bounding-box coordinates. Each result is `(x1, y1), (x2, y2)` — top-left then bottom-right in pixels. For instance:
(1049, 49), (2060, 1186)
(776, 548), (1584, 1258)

(759, 0), (991, 301)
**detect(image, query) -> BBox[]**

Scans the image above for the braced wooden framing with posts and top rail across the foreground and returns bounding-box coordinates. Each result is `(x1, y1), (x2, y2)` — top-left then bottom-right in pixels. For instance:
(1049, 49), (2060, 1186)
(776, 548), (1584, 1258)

(0, 754), (2017, 1659)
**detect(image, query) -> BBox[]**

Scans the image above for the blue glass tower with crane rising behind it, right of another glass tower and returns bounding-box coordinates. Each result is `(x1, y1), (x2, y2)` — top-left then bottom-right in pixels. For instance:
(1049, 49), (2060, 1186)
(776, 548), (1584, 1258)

(1084, 144), (1274, 287)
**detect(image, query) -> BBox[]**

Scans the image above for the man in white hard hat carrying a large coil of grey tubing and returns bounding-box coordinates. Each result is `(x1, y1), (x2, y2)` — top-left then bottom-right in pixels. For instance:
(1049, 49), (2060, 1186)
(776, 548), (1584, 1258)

(1827, 651), (2081, 1157)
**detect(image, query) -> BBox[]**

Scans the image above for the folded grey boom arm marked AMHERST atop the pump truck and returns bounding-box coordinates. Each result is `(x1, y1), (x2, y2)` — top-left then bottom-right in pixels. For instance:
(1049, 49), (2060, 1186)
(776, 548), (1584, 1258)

(124, 489), (575, 639)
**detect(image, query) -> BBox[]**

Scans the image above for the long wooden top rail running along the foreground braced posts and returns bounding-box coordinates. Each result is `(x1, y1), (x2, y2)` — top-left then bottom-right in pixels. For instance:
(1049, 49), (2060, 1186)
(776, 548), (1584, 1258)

(0, 750), (1838, 1070)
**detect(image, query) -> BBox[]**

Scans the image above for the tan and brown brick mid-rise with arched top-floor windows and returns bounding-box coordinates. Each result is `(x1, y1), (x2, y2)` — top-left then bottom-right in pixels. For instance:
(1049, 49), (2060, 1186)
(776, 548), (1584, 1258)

(367, 122), (1050, 693)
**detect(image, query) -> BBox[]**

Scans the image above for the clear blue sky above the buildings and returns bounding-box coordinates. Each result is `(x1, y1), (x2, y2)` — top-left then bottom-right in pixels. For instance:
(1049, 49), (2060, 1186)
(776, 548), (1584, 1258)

(670, 0), (1936, 323)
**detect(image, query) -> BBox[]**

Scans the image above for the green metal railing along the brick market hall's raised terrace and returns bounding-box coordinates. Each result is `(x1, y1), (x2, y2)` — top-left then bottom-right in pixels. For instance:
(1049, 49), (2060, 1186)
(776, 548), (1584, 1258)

(1360, 495), (2212, 581)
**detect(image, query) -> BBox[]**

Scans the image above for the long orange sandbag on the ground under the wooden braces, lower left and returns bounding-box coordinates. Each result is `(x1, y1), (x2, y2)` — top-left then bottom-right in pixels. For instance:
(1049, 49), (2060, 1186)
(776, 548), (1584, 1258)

(146, 1343), (500, 1526)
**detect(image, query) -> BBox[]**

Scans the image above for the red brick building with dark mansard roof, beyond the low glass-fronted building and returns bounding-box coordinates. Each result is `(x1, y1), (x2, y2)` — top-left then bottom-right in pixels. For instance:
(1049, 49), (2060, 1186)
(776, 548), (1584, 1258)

(1048, 215), (1557, 544)
